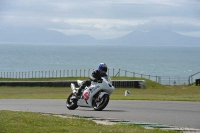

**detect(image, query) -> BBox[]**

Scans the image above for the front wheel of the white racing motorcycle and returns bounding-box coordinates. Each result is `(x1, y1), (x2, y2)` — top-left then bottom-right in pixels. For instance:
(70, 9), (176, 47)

(92, 94), (110, 111)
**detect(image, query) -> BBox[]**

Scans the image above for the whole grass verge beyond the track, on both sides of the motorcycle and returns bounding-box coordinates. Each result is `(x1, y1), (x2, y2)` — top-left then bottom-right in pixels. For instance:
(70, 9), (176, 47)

(0, 77), (200, 101)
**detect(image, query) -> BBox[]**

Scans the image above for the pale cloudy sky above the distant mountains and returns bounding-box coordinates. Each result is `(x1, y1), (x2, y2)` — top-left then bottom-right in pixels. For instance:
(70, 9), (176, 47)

(0, 0), (200, 39)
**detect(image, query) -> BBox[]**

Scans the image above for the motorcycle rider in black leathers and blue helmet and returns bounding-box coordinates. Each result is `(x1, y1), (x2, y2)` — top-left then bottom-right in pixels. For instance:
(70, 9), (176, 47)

(75, 63), (108, 99)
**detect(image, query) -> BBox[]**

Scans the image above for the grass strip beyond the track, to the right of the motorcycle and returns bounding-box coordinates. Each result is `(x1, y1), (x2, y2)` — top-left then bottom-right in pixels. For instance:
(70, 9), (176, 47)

(111, 86), (200, 101)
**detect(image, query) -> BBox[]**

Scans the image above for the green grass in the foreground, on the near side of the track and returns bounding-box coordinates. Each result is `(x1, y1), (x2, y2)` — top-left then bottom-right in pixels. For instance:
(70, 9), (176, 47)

(0, 111), (177, 133)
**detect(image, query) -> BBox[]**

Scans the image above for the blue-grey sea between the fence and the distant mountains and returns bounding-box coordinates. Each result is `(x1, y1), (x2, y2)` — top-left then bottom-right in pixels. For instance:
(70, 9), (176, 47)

(0, 43), (200, 77)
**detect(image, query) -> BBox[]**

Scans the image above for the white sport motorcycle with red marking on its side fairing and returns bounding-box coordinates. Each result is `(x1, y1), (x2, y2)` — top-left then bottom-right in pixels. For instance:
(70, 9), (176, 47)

(66, 76), (115, 111)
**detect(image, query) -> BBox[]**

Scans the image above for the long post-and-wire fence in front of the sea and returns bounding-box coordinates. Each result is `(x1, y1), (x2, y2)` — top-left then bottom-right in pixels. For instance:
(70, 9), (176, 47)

(0, 68), (200, 85)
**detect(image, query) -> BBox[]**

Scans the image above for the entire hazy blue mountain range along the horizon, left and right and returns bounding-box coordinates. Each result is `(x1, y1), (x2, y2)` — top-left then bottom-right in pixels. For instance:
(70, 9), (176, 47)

(0, 28), (200, 46)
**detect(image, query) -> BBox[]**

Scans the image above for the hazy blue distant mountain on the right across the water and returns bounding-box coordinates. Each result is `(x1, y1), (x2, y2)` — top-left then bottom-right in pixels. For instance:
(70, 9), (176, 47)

(102, 30), (200, 46)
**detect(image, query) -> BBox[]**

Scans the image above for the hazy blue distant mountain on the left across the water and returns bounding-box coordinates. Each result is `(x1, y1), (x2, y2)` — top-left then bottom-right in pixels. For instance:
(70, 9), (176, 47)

(0, 28), (96, 44)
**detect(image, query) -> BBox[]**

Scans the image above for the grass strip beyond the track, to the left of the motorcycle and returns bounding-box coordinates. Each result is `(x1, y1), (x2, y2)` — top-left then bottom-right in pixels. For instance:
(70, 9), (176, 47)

(0, 86), (68, 99)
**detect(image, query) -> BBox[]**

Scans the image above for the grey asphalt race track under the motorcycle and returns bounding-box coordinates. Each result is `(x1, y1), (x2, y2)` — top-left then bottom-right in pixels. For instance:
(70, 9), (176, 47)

(0, 99), (200, 129)
